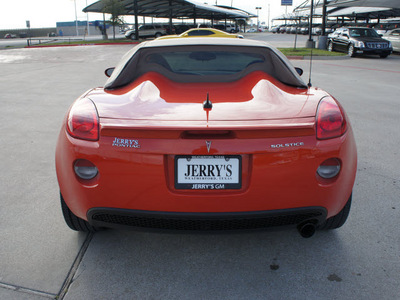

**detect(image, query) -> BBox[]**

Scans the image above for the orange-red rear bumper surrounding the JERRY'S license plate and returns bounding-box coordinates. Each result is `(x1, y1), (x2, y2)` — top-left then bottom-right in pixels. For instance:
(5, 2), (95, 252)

(56, 119), (357, 223)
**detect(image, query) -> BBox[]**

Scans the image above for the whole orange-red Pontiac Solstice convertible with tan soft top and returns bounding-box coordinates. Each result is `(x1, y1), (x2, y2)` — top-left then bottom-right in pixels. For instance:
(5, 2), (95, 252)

(56, 38), (357, 237)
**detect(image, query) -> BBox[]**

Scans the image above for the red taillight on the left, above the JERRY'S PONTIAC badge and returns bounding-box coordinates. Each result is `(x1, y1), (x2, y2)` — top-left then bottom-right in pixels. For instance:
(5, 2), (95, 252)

(67, 99), (99, 141)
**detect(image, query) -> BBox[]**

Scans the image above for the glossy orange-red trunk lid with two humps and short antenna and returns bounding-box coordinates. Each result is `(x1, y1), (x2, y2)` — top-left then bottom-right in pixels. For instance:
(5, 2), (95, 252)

(87, 74), (324, 126)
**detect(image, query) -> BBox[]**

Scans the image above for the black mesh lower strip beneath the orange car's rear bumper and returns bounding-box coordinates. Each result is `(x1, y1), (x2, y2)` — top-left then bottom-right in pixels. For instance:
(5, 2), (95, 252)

(87, 207), (327, 231)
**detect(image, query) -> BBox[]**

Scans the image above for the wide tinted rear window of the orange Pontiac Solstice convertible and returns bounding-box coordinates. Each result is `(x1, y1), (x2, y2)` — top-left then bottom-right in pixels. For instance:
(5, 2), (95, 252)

(106, 45), (305, 89)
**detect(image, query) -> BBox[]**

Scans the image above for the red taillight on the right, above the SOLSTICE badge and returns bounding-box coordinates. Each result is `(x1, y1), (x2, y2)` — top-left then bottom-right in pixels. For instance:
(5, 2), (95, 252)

(317, 97), (347, 140)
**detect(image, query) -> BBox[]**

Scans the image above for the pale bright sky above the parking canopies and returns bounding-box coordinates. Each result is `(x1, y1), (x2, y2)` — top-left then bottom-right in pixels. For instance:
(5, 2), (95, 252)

(0, 0), (305, 29)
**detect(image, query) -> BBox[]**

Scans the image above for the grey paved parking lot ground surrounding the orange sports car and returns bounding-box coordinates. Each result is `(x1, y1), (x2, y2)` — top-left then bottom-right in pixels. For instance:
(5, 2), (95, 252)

(0, 33), (400, 300)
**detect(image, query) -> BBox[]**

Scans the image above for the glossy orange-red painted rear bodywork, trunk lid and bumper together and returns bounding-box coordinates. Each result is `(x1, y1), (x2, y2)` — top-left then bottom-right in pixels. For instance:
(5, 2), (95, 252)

(56, 72), (357, 220)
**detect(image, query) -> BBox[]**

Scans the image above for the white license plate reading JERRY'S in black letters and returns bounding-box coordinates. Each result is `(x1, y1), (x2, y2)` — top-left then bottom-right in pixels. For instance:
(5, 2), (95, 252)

(175, 155), (242, 190)
